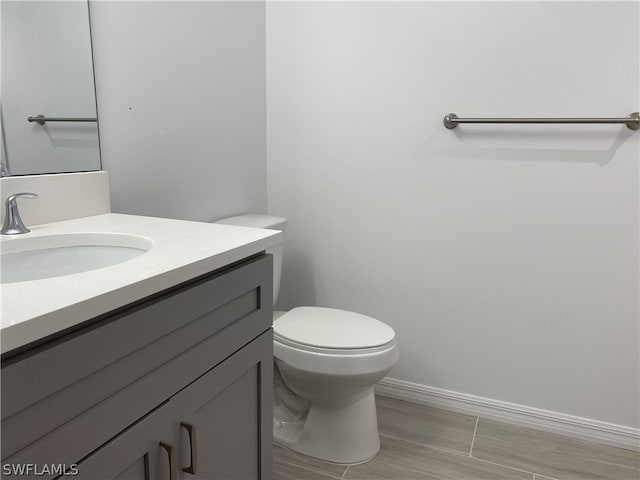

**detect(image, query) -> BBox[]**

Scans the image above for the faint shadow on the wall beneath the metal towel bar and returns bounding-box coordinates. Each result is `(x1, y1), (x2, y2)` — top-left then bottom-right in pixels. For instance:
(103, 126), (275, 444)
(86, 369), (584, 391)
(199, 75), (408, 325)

(414, 126), (638, 167)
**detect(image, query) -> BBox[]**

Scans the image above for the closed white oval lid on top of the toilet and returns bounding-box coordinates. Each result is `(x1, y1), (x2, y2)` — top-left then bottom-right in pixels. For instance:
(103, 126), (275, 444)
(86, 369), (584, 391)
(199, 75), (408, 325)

(273, 307), (396, 349)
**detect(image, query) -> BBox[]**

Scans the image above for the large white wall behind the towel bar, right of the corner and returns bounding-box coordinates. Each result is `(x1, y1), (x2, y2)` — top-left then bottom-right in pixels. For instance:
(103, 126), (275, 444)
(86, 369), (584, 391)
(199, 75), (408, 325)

(267, 2), (640, 427)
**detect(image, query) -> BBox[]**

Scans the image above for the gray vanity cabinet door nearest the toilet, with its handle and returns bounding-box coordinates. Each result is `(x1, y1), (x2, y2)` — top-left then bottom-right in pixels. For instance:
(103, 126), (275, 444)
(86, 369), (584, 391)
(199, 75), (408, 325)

(171, 329), (273, 480)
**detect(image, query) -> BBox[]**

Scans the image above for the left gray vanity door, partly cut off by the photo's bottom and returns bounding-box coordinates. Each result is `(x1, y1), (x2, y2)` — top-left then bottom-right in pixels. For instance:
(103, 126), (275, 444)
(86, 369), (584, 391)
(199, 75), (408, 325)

(73, 403), (177, 480)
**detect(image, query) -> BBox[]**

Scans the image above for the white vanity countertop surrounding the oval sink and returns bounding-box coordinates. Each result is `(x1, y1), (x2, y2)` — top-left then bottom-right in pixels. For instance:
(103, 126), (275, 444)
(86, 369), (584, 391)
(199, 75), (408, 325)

(0, 213), (282, 353)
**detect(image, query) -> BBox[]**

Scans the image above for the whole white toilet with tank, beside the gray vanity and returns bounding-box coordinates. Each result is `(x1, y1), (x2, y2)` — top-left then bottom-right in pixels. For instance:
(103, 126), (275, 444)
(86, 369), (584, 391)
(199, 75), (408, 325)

(216, 214), (398, 464)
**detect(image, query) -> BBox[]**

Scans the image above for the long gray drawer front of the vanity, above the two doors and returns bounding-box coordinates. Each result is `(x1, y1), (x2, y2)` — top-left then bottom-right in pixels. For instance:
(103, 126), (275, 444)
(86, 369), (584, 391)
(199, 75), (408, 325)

(2, 255), (272, 461)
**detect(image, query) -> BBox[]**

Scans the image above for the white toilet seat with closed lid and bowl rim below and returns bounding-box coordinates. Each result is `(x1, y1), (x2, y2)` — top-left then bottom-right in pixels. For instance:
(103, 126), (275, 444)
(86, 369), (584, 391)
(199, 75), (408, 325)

(273, 307), (398, 375)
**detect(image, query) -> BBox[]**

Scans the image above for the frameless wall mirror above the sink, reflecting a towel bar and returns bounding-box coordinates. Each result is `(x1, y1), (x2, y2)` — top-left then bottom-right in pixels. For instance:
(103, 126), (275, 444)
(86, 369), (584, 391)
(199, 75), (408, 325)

(0, 0), (100, 176)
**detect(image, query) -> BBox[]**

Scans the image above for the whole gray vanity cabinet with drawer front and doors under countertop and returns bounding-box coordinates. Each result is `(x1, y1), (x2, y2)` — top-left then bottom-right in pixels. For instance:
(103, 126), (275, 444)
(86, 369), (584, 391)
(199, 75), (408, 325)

(2, 254), (273, 480)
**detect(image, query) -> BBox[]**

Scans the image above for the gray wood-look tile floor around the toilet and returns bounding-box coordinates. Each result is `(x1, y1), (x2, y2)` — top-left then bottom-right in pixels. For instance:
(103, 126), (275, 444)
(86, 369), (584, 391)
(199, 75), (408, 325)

(273, 397), (640, 480)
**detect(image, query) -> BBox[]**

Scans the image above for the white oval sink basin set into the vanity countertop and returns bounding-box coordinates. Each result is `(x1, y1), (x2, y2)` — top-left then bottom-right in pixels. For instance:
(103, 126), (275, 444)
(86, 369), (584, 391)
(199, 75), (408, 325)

(0, 233), (153, 283)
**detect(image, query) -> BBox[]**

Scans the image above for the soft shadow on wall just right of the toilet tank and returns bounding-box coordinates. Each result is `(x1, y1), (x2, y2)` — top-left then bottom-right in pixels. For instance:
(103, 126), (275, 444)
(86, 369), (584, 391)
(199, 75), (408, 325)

(275, 245), (317, 310)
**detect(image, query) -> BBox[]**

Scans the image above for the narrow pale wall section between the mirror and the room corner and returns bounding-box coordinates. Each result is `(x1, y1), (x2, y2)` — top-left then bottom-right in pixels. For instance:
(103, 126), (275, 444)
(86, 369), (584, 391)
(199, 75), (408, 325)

(91, 2), (266, 221)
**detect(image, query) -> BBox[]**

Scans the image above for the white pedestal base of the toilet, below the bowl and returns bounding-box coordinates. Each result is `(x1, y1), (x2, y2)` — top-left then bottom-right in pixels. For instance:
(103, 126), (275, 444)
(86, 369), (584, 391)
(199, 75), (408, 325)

(273, 387), (380, 465)
